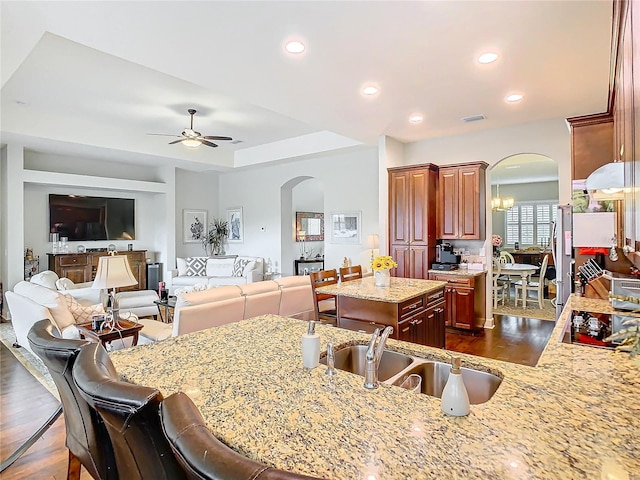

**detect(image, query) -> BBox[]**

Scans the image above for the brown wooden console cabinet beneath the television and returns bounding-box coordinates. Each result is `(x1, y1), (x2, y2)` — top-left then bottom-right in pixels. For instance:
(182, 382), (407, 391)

(47, 250), (147, 292)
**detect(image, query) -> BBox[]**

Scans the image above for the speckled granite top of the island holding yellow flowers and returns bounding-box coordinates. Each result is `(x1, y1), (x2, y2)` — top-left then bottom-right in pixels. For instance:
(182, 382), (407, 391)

(316, 277), (447, 303)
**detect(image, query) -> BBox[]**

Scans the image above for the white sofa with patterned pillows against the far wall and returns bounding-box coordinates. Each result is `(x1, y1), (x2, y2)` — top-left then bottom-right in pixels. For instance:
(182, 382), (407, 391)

(167, 256), (264, 295)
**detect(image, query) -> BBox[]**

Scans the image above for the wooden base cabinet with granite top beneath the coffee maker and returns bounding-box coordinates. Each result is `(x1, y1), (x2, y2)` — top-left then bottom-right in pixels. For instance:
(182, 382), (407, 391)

(429, 272), (486, 330)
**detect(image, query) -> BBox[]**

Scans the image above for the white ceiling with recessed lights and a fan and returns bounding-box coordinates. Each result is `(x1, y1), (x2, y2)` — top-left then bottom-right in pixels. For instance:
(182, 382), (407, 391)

(0, 0), (612, 170)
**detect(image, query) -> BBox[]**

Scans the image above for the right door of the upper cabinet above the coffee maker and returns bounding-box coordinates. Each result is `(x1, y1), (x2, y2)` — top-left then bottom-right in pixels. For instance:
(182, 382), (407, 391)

(458, 166), (486, 240)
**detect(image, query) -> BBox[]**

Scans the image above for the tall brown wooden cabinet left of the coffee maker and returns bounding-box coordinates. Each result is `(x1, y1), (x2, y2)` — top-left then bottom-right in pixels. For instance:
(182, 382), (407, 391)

(388, 164), (438, 279)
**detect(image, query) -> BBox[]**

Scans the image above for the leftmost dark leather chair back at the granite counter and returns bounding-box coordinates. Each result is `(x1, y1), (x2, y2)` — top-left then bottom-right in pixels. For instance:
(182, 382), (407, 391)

(27, 319), (118, 479)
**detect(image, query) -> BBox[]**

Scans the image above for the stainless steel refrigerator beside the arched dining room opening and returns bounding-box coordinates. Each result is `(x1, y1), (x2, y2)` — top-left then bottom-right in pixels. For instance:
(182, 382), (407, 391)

(552, 205), (574, 320)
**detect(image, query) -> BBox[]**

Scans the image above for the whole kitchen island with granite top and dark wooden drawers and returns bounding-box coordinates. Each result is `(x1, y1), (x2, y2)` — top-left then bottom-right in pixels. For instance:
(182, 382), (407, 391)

(316, 277), (447, 348)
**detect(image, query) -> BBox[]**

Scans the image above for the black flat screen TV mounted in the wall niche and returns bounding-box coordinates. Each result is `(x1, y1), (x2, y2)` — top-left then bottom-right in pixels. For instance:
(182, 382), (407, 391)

(49, 194), (136, 241)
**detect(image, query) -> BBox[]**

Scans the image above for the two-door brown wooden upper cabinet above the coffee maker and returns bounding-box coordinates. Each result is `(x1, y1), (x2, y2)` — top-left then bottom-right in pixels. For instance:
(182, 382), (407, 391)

(437, 162), (487, 240)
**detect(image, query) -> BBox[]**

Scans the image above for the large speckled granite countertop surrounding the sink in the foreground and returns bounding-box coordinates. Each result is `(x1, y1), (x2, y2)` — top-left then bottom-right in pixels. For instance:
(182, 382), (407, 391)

(111, 296), (640, 480)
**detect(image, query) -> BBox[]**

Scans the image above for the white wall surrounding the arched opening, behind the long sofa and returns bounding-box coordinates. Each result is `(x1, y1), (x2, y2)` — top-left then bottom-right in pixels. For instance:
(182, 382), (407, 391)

(219, 148), (384, 276)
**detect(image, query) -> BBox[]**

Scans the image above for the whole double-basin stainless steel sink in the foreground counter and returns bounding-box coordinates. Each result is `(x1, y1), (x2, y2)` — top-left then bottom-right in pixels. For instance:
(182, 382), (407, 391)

(320, 345), (502, 405)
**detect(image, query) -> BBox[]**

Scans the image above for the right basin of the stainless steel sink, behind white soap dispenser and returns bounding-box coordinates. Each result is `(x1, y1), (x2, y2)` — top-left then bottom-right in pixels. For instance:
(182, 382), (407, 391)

(393, 361), (502, 405)
